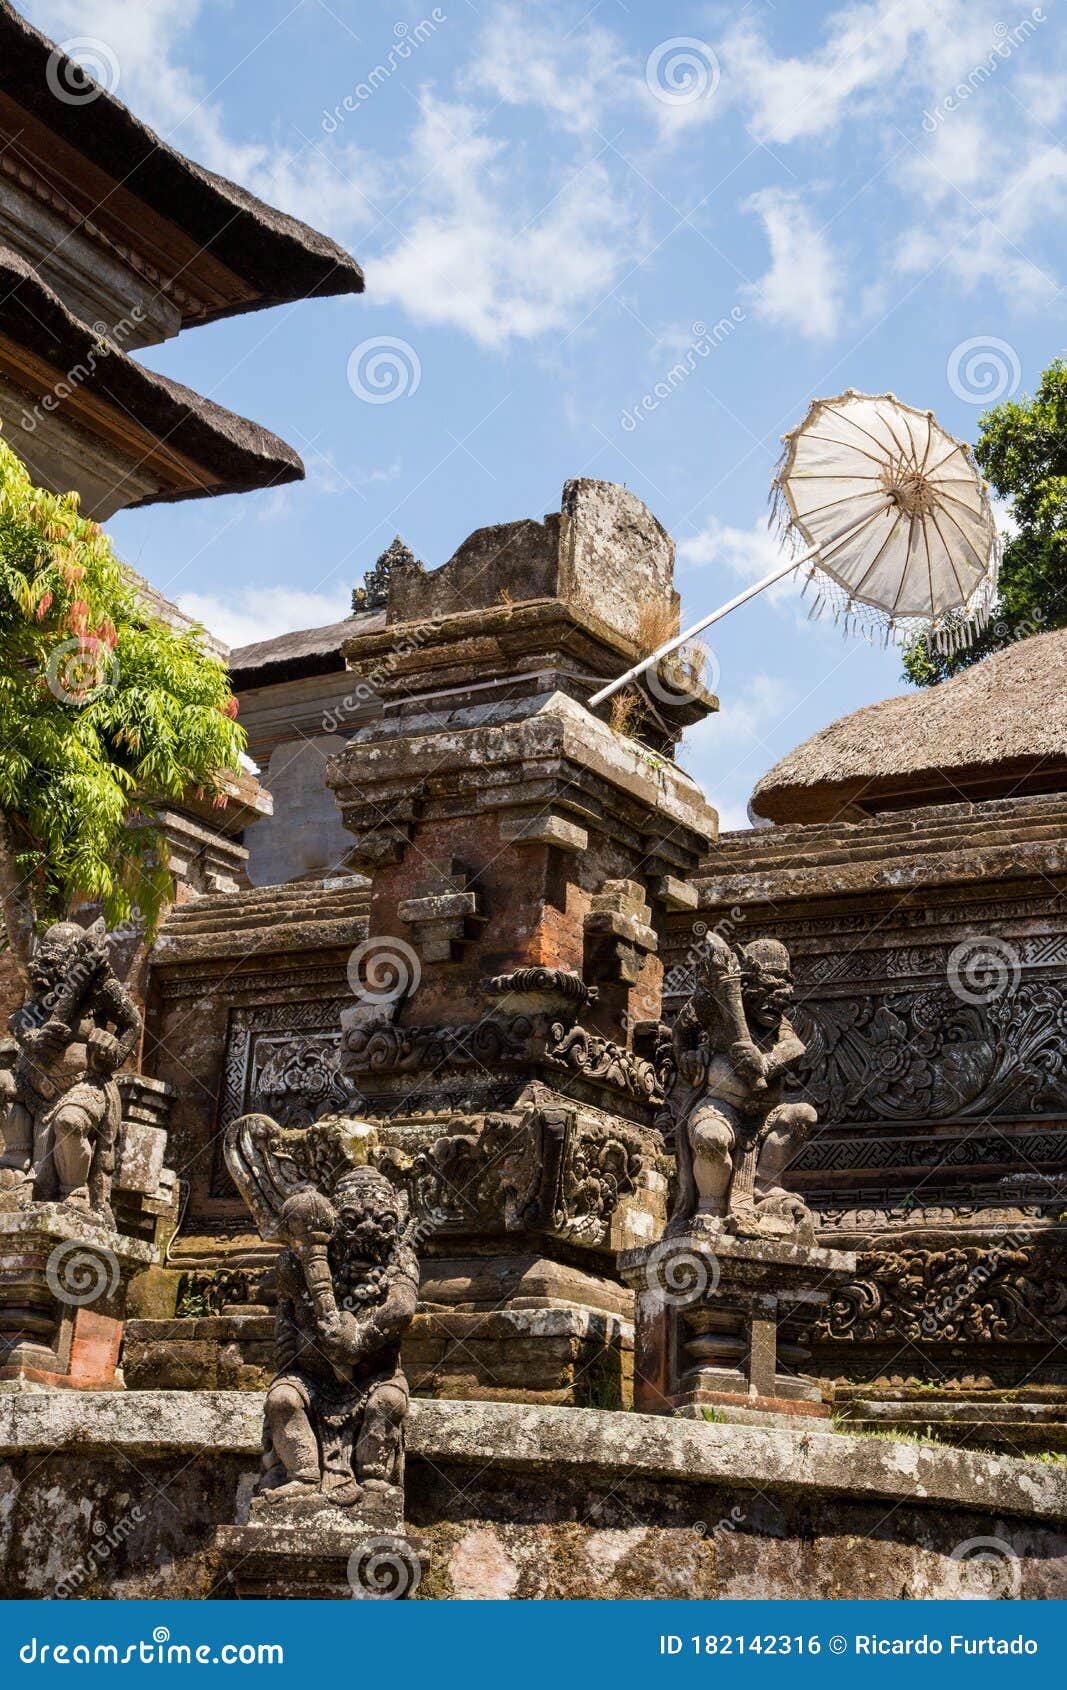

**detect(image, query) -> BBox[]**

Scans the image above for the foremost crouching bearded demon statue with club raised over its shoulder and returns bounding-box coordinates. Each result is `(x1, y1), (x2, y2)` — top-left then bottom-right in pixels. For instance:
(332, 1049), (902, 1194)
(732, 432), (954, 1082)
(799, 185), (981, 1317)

(225, 1115), (419, 1519)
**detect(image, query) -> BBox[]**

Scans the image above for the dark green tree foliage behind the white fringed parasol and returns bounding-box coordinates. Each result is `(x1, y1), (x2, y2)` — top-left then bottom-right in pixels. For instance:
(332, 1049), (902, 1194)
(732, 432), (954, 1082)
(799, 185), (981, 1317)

(905, 358), (1067, 686)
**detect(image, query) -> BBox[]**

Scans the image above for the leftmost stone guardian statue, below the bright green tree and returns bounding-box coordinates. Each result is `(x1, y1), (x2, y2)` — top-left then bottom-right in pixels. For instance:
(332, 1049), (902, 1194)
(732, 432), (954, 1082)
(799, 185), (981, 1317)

(0, 921), (140, 1224)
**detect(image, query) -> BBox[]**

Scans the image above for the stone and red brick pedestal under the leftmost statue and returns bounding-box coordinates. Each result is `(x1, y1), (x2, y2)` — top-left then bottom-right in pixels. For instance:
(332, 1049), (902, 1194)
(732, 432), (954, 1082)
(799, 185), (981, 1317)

(0, 1203), (156, 1391)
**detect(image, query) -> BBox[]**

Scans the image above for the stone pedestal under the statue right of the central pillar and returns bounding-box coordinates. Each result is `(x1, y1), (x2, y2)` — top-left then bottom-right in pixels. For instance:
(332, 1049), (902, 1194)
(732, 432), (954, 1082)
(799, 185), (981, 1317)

(619, 1232), (856, 1425)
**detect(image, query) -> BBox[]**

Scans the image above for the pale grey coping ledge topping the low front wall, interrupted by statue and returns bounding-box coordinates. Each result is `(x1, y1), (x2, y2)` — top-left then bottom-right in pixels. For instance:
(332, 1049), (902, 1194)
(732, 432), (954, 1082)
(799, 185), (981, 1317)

(0, 1391), (1067, 1524)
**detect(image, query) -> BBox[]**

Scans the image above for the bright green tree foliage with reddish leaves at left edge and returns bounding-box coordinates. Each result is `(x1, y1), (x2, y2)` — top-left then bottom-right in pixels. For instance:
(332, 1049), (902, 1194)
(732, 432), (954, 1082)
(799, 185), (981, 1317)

(0, 429), (245, 951)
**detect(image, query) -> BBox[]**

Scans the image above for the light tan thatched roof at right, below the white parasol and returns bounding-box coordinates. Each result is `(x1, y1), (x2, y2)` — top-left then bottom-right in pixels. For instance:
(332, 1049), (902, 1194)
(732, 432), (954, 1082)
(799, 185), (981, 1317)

(752, 629), (1067, 821)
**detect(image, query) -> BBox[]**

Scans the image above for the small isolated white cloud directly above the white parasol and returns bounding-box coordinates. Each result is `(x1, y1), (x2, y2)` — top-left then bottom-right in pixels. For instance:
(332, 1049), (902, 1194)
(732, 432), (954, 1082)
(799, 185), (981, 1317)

(744, 188), (842, 340)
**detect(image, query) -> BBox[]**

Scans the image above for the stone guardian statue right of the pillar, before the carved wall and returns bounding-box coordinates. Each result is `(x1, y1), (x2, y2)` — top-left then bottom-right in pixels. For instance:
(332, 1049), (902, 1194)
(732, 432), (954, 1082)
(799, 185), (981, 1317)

(668, 935), (817, 1242)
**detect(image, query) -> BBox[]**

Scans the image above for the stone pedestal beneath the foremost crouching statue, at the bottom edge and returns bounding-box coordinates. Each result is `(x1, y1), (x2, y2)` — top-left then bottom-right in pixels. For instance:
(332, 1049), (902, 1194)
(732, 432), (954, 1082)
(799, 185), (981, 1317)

(215, 1486), (428, 1602)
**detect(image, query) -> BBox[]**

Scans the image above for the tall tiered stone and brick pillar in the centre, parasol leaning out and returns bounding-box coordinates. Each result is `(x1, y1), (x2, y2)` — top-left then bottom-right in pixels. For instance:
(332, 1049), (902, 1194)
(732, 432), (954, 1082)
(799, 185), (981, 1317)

(328, 482), (717, 1403)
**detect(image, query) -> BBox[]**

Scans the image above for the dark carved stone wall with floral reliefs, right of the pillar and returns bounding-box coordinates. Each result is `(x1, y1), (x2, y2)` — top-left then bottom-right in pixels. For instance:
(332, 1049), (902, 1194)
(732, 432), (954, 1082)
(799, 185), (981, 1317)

(665, 796), (1067, 1386)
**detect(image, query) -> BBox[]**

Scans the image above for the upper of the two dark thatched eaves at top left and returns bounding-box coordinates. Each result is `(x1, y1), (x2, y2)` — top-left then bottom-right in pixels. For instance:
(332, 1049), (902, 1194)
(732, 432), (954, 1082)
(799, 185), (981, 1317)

(0, 0), (364, 323)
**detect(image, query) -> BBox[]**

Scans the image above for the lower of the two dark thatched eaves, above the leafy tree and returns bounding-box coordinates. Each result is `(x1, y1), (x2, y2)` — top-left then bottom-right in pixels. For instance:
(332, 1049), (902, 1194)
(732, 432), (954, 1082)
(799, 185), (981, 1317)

(0, 247), (304, 504)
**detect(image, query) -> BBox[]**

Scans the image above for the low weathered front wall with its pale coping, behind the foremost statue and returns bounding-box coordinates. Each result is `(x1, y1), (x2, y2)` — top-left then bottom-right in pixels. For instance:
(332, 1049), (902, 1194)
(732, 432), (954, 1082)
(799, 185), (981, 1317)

(0, 1391), (1067, 1602)
